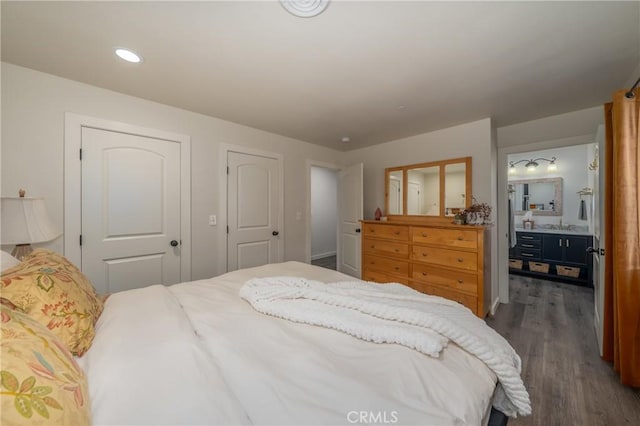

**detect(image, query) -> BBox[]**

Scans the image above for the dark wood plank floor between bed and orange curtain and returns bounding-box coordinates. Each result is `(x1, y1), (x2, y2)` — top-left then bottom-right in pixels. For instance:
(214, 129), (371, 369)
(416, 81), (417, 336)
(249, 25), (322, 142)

(487, 275), (640, 426)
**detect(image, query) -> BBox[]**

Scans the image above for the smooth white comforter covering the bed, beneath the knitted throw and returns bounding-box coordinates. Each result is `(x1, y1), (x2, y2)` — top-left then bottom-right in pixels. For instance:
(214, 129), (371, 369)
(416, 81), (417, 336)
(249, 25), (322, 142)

(80, 262), (508, 425)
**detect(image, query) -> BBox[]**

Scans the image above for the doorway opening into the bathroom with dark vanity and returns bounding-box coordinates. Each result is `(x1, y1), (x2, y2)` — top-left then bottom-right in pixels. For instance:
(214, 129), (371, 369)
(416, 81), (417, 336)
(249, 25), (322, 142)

(498, 140), (602, 316)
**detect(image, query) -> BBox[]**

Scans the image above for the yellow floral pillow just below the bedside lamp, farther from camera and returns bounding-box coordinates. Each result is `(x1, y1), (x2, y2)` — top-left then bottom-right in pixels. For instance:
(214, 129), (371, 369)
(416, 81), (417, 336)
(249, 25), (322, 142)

(0, 249), (104, 356)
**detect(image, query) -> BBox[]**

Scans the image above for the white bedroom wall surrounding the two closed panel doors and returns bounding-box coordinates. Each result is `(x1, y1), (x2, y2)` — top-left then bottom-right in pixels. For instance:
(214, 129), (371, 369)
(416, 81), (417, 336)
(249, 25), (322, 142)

(1, 63), (342, 279)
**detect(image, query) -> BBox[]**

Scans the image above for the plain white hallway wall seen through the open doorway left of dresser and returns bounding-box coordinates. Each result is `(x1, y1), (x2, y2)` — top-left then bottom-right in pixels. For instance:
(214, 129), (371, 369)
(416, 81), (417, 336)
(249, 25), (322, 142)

(311, 167), (338, 260)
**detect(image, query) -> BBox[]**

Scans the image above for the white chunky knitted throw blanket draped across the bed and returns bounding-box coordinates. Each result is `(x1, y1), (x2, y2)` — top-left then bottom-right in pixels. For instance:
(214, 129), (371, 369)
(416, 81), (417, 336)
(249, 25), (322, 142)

(240, 277), (531, 417)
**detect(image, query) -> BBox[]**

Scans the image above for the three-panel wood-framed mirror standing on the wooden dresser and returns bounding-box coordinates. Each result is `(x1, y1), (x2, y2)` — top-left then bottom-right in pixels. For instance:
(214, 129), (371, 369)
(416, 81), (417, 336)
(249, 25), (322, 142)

(385, 157), (471, 218)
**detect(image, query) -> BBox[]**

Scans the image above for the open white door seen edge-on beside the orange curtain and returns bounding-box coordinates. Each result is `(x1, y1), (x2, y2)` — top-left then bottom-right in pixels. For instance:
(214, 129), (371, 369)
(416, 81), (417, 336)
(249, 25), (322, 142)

(593, 125), (606, 355)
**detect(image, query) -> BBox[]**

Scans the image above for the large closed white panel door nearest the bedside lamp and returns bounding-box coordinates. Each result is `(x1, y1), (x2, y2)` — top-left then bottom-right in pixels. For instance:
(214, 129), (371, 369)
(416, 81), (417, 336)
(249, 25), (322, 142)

(81, 127), (180, 293)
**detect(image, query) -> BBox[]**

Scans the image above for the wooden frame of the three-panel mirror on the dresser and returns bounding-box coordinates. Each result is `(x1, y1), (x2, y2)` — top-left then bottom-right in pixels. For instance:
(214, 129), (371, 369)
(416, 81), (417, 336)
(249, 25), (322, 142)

(384, 157), (473, 221)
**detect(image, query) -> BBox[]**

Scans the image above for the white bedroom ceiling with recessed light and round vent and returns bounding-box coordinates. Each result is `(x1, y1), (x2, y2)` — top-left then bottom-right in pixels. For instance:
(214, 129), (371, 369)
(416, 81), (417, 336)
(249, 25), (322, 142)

(1, 0), (640, 150)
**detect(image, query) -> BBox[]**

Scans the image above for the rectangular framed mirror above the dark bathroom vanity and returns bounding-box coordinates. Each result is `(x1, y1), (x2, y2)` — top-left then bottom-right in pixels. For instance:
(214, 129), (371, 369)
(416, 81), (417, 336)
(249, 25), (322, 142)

(509, 178), (562, 216)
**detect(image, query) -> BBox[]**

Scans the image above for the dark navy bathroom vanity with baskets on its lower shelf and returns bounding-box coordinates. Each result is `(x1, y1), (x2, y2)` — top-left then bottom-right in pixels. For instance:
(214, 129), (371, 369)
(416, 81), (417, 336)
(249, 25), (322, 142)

(509, 228), (593, 287)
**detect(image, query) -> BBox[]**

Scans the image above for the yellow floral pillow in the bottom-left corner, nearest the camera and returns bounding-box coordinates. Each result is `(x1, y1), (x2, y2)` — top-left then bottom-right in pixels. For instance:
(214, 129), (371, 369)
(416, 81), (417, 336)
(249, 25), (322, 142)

(0, 304), (91, 425)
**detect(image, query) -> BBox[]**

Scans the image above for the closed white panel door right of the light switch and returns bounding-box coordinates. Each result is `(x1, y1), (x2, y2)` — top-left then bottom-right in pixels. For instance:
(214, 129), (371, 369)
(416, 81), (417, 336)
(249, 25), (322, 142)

(227, 151), (282, 271)
